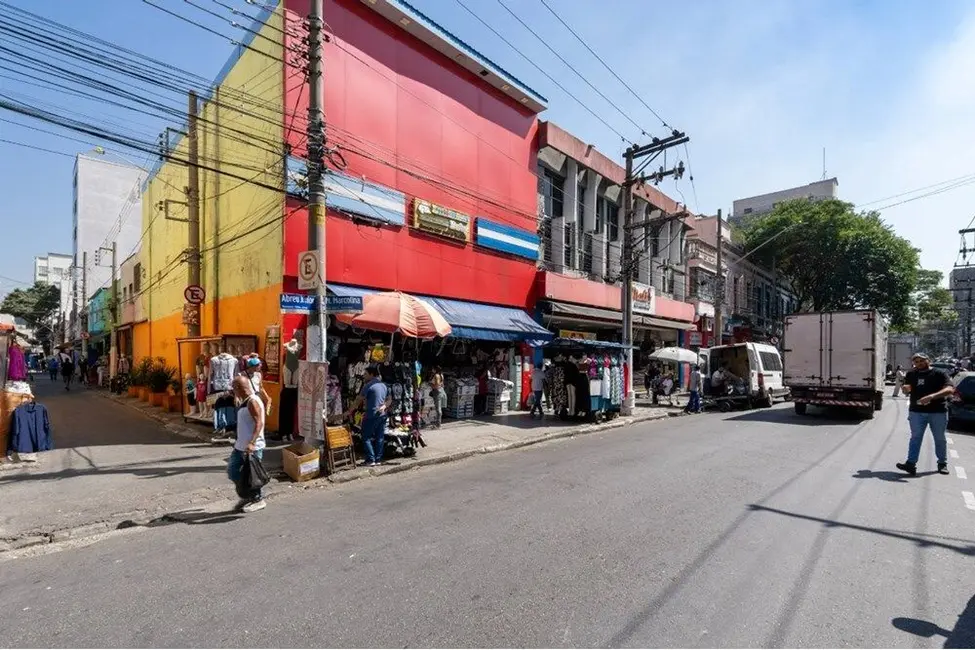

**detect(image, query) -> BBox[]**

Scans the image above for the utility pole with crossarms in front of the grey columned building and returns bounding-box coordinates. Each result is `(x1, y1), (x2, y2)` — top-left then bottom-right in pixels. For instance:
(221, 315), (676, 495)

(620, 130), (690, 415)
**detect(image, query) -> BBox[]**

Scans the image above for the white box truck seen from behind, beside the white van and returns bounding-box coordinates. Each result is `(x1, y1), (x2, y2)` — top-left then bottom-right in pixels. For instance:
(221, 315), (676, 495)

(783, 309), (887, 418)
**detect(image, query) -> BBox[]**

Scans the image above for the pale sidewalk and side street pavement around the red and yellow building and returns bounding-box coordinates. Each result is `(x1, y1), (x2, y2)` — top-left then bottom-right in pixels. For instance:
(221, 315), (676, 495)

(0, 380), (676, 551)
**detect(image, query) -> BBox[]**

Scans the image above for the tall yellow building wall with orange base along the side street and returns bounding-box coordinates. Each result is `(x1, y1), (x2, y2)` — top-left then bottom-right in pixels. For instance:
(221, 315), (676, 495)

(133, 8), (284, 428)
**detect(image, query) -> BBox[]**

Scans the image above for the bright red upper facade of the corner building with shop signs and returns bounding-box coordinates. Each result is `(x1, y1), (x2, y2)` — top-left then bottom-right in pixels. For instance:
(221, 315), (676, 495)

(283, 0), (544, 309)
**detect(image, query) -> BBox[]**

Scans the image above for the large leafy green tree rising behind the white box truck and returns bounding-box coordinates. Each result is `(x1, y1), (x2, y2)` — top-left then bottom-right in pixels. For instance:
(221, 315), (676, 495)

(743, 199), (918, 326)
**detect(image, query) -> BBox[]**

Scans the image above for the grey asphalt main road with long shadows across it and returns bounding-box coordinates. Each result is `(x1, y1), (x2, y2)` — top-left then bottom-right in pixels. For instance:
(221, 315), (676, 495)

(0, 401), (975, 647)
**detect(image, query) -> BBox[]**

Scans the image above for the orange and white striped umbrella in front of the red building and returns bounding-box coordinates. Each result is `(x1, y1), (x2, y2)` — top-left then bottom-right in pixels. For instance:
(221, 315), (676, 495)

(335, 291), (451, 339)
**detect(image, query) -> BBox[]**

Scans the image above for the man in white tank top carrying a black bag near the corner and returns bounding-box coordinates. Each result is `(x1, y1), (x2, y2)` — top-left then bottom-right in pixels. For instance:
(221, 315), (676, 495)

(227, 375), (267, 512)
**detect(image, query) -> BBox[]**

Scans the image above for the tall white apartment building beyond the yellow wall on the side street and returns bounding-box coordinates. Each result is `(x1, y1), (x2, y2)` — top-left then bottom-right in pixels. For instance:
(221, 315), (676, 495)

(72, 150), (147, 338)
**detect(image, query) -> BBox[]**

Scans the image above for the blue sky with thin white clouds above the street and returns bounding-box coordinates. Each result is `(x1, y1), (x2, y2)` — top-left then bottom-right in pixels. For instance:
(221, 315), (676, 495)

(0, 0), (975, 294)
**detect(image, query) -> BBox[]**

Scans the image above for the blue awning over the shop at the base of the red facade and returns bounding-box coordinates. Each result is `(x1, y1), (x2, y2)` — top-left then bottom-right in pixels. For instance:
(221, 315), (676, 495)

(420, 296), (553, 346)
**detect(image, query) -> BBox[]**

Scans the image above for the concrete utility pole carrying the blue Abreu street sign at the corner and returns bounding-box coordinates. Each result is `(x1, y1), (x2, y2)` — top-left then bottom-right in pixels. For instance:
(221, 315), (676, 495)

(307, 0), (328, 372)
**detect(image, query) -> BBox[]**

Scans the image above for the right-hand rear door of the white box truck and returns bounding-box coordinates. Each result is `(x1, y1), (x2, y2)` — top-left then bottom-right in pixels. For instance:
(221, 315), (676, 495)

(824, 311), (877, 389)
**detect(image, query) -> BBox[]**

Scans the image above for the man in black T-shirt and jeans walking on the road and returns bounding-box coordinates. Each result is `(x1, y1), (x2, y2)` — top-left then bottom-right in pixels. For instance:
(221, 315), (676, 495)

(897, 353), (955, 476)
